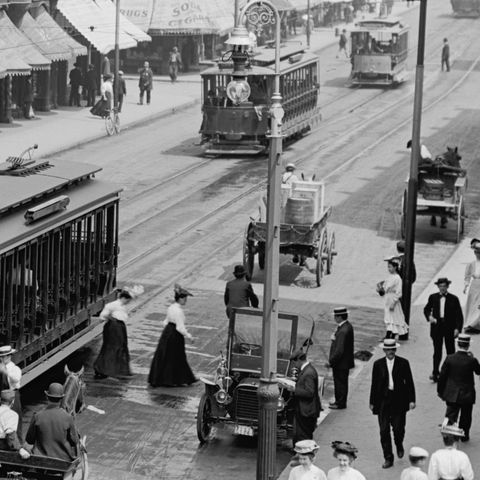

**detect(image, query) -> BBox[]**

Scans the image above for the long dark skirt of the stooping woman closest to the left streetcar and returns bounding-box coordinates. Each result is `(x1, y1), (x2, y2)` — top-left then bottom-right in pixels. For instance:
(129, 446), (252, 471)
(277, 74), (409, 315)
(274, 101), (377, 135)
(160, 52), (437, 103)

(93, 318), (132, 377)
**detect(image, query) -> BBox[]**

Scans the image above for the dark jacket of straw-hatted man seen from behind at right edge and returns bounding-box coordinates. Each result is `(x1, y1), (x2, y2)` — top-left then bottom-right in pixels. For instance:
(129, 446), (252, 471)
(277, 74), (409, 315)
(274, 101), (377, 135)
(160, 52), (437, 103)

(437, 350), (480, 405)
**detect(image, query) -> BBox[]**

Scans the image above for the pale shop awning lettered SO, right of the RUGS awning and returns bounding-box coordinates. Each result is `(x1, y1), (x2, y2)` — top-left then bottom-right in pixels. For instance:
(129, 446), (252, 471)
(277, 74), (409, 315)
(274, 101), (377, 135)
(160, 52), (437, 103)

(148, 0), (234, 35)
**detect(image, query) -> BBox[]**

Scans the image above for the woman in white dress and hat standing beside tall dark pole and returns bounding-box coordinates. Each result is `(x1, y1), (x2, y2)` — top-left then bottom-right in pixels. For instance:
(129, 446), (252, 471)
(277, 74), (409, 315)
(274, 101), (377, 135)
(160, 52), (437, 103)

(377, 257), (408, 338)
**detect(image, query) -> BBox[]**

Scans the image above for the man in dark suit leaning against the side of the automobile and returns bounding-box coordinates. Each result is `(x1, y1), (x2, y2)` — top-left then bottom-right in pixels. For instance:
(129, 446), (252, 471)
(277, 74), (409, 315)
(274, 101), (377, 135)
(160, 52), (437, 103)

(290, 350), (322, 445)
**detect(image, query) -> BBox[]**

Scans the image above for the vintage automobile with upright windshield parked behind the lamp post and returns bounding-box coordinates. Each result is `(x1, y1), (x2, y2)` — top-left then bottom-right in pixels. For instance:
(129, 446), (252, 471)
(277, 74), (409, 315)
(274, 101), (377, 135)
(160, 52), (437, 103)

(197, 308), (314, 443)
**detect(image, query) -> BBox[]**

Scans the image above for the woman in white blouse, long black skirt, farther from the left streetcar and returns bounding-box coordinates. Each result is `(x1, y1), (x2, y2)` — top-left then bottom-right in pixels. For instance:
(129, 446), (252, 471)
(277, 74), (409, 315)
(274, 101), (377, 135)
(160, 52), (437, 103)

(148, 285), (197, 387)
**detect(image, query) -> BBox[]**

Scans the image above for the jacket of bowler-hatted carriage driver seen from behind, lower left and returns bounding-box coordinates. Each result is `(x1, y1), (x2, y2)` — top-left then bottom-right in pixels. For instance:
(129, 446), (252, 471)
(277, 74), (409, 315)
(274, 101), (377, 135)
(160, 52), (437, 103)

(25, 404), (78, 461)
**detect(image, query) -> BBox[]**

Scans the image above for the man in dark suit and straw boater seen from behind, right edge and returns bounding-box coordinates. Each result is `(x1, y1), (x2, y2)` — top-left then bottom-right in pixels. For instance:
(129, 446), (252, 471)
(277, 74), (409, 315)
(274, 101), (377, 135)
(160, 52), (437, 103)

(437, 333), (480, 442)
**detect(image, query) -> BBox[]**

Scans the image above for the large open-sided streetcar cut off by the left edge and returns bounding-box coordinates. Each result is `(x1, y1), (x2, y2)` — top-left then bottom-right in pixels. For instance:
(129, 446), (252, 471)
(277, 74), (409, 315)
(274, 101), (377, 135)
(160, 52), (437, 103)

(0, 145), (120, 384)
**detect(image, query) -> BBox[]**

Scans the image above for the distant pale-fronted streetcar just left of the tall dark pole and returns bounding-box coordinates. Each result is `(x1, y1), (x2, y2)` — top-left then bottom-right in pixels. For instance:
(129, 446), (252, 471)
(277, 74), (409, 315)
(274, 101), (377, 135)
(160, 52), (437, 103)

(350, 18), (409, 86)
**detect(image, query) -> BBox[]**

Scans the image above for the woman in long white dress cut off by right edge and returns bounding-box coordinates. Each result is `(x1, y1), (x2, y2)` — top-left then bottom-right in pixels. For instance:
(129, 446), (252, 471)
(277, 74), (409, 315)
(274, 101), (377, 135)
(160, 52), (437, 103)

(463, 238), (480, 332)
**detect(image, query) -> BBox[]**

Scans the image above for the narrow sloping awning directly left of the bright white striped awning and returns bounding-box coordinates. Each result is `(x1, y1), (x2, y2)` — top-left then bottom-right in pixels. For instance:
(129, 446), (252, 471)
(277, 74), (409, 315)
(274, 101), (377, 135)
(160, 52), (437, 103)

(32, 5), (87, 60)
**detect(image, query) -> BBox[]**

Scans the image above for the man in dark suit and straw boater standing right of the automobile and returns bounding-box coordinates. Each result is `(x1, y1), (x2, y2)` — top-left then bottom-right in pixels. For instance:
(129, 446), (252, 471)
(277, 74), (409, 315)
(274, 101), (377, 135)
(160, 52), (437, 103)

(328, 307), (355, 410)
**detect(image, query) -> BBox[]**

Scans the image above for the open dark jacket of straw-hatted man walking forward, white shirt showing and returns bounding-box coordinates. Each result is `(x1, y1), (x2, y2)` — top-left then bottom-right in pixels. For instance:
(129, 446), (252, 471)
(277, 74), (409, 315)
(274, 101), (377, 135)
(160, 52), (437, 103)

(370, 356), (415, 415)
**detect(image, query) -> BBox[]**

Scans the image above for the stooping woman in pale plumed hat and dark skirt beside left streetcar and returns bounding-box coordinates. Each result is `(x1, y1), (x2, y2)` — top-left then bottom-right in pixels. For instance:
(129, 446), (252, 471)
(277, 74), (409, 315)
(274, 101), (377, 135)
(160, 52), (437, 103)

(93, 286), (143, 378)
